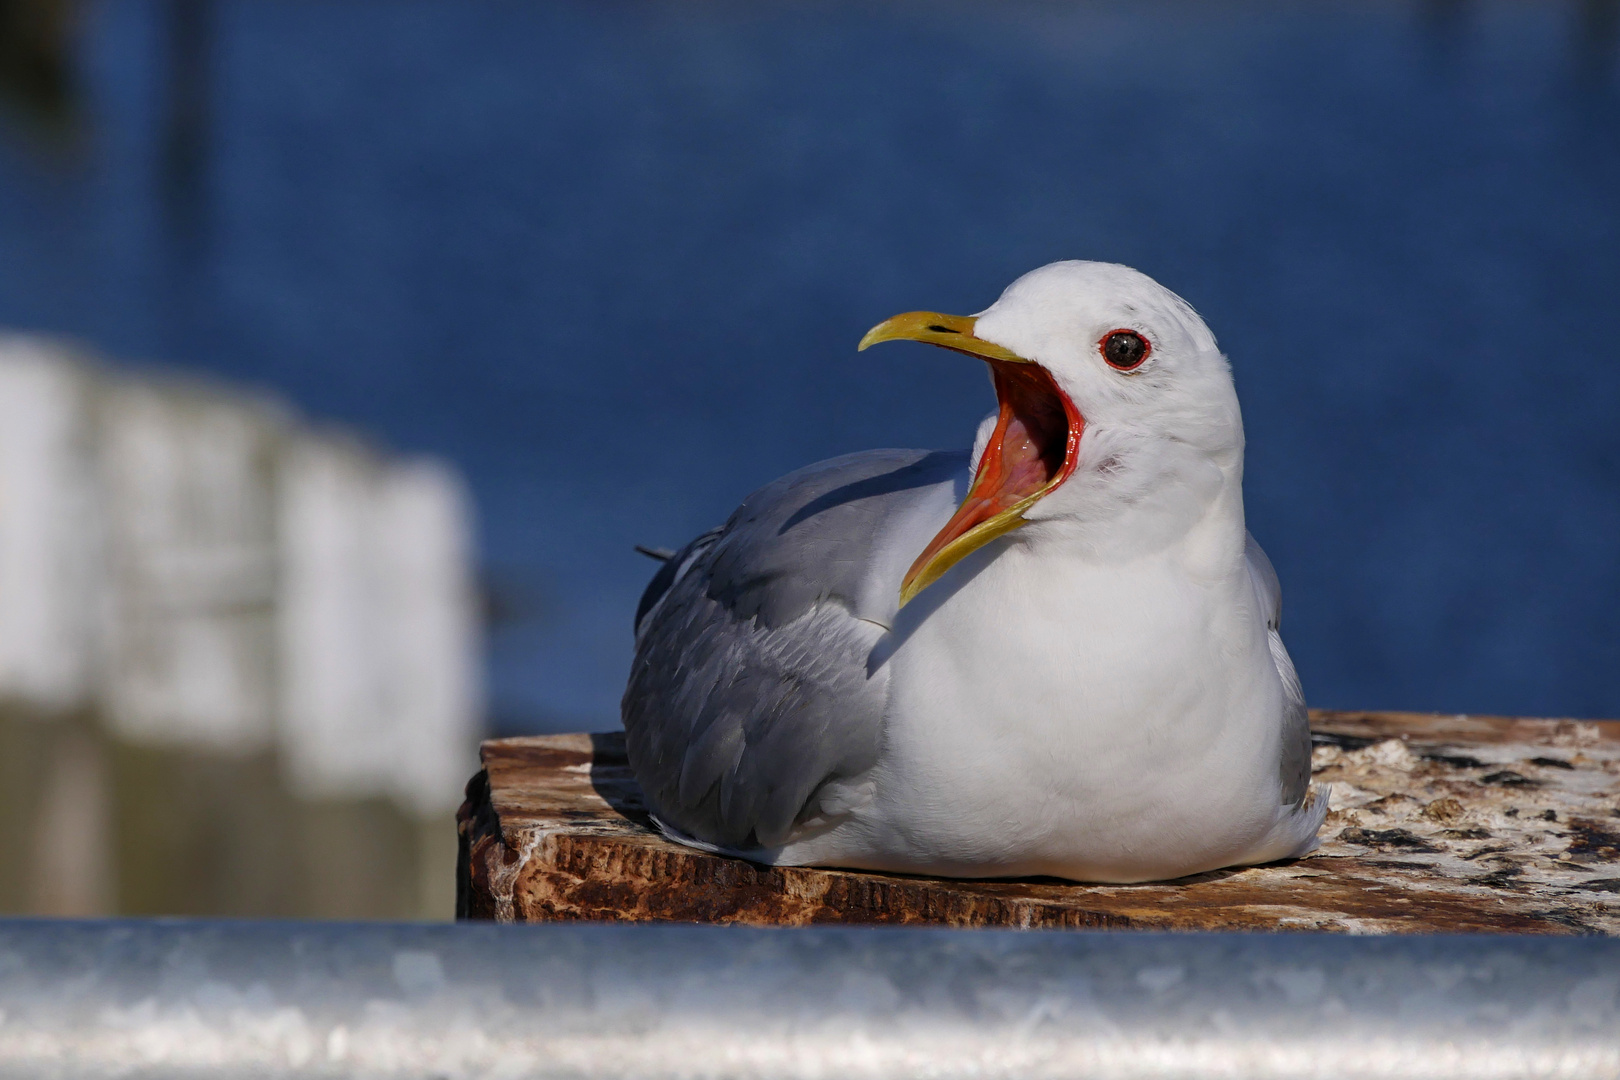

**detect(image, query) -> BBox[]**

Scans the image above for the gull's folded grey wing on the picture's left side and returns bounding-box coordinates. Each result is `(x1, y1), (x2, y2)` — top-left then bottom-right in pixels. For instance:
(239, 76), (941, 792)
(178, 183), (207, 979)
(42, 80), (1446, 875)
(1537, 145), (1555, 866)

(622, 450), (967, 850)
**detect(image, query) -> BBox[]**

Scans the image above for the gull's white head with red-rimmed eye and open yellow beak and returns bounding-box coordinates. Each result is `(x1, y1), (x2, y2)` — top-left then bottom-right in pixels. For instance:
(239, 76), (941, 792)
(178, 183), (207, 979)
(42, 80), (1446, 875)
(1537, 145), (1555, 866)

(860, 262), (1243, 602)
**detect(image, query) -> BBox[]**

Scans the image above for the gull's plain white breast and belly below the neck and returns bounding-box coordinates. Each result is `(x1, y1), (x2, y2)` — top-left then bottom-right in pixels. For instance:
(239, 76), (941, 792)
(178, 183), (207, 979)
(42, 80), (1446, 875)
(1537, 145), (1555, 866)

(782, 544), (1285, 881)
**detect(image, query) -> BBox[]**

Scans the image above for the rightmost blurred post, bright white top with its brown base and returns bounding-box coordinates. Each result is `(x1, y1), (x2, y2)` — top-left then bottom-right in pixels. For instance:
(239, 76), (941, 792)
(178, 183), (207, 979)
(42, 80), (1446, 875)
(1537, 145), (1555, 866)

(279, 434), (481, 918)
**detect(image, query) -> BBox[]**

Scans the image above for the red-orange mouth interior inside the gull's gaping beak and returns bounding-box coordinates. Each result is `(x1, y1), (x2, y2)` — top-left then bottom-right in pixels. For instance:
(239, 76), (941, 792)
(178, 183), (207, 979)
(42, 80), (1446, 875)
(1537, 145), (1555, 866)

(906, 359), (1085, 581)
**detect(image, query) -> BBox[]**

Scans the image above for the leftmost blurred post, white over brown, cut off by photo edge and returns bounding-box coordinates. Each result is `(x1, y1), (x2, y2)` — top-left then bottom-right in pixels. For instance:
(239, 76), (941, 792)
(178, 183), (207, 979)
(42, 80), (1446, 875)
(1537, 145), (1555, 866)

(0, 335), (112, 915)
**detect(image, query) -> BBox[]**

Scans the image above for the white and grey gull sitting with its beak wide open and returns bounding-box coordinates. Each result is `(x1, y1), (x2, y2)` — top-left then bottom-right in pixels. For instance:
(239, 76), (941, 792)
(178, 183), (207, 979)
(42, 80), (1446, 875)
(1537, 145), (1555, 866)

(622, 261), (1328, 882)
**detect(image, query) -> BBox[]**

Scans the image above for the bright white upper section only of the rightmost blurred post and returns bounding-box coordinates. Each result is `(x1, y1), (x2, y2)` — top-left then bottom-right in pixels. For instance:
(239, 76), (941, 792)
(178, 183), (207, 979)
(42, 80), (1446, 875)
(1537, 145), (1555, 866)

(280, 437), (481, 814)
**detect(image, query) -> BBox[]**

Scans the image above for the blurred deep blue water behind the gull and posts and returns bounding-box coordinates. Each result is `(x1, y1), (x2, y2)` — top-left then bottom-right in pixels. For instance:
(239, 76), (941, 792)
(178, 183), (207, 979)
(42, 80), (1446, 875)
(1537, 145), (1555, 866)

(0, 0), (1620, 730)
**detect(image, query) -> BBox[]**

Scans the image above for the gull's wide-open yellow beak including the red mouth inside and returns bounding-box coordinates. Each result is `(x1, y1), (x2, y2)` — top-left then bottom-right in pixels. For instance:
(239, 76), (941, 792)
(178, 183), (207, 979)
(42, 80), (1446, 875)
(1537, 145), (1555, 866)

(860, 311), (1085, 607)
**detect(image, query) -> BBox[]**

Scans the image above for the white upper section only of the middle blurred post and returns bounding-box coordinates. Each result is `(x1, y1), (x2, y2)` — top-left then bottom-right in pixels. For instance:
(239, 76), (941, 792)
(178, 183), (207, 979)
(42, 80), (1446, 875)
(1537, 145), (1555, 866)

(97, 377), (284, 755)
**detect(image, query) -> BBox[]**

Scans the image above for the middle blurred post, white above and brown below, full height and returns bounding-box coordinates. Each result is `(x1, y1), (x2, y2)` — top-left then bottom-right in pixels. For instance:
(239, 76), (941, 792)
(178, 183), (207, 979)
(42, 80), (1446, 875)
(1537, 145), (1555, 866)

(97, 376), (301, 915)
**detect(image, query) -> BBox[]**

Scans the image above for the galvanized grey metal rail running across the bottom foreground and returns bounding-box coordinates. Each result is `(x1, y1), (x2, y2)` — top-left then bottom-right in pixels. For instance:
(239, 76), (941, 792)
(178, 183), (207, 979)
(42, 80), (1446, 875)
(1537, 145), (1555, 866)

(0, 921), (1620, 1080)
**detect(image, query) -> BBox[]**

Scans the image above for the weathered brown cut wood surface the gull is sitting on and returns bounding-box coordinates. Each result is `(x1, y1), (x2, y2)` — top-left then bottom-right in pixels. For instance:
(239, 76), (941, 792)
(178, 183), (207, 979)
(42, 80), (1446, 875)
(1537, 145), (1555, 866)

(457, 711), (1620, 934)
